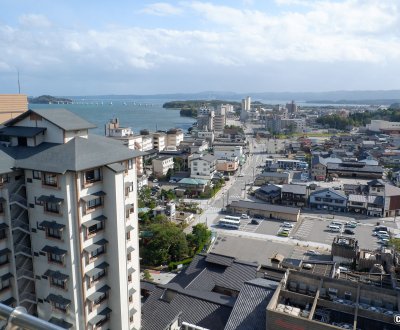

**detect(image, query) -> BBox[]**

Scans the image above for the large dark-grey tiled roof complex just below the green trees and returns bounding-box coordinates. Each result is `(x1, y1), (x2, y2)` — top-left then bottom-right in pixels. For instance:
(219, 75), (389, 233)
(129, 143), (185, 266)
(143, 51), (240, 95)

(142, 254), (258, 330)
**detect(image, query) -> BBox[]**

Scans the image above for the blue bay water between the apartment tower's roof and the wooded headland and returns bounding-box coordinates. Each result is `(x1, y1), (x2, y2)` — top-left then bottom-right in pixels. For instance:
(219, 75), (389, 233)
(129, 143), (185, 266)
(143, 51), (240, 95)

(29, 97), (196, 135)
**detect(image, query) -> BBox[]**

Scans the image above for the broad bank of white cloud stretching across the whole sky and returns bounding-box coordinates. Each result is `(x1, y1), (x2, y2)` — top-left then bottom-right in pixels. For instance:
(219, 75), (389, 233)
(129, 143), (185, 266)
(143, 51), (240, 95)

(0, 0), (400, 93)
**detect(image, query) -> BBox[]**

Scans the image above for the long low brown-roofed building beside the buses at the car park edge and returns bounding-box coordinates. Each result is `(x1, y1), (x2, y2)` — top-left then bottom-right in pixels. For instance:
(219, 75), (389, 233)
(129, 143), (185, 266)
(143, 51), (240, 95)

(227, 201), (300, 221)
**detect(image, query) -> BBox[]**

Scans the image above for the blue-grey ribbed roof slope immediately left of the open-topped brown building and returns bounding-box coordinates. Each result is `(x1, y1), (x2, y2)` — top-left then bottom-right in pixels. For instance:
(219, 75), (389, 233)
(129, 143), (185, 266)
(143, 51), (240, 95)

(225, 278), (278, 330)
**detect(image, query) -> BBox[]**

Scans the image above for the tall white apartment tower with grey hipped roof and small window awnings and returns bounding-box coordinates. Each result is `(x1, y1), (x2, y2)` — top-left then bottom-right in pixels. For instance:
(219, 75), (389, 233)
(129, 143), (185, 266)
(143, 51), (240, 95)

(0, 109), (141, 330)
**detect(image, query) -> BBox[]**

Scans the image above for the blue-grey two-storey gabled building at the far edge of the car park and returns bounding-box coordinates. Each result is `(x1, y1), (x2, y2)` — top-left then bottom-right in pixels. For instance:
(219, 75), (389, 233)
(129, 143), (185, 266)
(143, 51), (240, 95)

(310, 188), (347, 212)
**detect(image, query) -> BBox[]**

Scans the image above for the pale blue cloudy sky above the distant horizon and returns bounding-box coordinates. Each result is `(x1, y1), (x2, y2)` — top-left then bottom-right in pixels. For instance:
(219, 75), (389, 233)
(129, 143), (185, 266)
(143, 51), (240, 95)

(0, 0), (400, 96)
